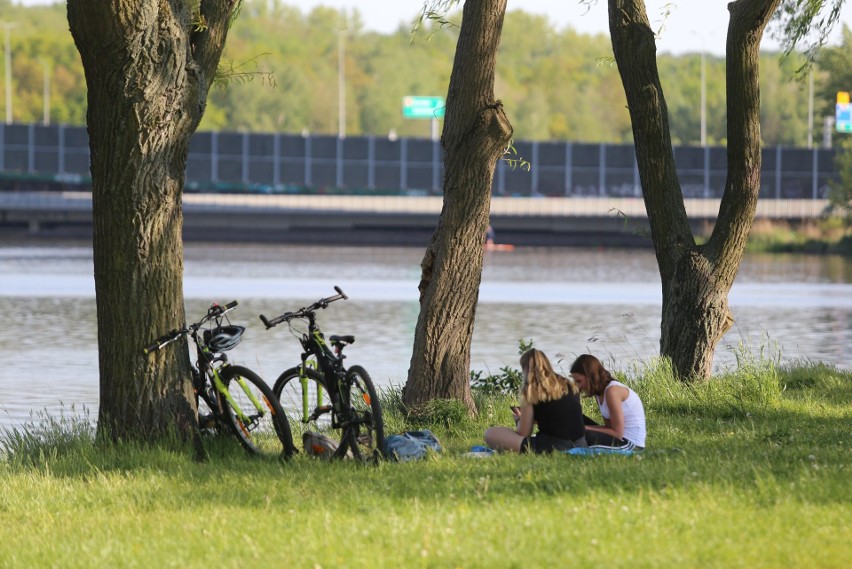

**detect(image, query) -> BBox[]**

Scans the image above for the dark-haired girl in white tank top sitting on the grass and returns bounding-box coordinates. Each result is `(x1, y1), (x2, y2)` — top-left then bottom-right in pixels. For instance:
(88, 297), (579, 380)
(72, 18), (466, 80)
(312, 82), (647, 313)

(571, 354), (645, 450)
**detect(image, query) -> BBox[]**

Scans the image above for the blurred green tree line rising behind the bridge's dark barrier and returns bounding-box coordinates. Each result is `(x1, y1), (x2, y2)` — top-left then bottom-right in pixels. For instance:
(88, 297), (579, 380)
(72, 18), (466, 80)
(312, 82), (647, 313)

(0, 0), (852, 146)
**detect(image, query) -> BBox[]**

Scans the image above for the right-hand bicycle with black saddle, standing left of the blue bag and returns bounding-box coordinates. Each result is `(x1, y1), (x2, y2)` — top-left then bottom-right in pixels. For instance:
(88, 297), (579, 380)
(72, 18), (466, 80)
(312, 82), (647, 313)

(260, 286), (385, 460)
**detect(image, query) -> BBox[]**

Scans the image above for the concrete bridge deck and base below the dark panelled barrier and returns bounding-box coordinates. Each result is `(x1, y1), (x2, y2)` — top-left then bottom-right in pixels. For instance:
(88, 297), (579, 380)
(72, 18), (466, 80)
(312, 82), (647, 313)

(0, 191), (828, 246)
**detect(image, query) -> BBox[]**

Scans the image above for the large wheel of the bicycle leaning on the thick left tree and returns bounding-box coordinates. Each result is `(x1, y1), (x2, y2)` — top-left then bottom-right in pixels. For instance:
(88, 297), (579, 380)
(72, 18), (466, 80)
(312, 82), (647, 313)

(218, 365), (295, 458)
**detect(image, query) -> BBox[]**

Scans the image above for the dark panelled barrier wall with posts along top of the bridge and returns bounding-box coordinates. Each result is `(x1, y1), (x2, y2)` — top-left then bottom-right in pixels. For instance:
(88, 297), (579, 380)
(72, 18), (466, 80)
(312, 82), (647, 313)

(0, 124), (837, 200)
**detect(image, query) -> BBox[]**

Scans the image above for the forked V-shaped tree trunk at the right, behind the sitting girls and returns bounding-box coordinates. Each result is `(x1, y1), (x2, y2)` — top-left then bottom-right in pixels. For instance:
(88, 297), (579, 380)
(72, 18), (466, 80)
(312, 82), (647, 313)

(609, 0), (780, 379)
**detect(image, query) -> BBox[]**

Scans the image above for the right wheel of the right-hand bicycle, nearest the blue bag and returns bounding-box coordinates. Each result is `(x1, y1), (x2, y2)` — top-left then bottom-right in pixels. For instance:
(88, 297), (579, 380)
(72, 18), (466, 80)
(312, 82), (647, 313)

(335, 366), (385, 460)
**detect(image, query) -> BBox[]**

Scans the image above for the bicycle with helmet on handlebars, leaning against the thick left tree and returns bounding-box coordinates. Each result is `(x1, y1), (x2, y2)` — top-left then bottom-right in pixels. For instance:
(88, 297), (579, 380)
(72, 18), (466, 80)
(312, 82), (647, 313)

(143, 300), (295, 458)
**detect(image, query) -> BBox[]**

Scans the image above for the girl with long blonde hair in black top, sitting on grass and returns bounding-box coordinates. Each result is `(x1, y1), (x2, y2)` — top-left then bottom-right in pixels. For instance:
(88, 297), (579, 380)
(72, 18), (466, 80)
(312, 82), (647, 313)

(485, 348), (586, 453)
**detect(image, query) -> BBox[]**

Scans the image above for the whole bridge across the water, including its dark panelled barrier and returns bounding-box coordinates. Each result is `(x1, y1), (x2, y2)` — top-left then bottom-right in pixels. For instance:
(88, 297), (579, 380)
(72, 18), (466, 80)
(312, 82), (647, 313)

(0, 124), (837, 245)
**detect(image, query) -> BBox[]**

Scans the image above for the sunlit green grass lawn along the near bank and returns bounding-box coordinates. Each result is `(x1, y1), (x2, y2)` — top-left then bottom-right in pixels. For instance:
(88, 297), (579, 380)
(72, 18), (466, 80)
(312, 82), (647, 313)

(0, 359), (852, 568)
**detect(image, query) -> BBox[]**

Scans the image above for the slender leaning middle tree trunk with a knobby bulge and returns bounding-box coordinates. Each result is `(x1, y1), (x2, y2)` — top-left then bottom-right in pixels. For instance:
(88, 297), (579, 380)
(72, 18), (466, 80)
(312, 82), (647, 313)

(403, 0), (512, 411)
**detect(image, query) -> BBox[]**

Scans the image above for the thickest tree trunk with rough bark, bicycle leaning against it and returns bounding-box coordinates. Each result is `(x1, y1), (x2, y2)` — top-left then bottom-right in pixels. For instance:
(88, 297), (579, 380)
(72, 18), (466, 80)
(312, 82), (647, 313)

(68, 0), (233, 440)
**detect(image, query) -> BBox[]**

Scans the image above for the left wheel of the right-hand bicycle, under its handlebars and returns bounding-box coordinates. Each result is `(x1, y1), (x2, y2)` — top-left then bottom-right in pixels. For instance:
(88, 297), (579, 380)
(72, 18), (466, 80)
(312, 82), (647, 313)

(272, 367), (340, 454)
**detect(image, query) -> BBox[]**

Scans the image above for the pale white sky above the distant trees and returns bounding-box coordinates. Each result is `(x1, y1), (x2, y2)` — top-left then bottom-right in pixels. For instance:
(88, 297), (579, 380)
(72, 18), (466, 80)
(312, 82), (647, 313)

(17, 0), (852, 55)
